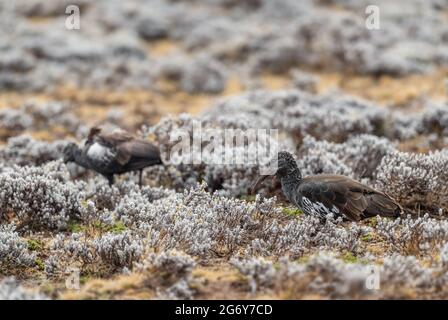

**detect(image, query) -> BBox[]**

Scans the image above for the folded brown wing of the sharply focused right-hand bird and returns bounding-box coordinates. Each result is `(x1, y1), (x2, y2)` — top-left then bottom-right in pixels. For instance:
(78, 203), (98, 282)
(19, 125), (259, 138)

(301, 175), (401, 221)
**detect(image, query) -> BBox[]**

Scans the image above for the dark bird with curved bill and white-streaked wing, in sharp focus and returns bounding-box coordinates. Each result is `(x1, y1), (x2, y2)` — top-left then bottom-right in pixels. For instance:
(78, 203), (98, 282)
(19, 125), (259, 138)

(252, 151), (403, 221)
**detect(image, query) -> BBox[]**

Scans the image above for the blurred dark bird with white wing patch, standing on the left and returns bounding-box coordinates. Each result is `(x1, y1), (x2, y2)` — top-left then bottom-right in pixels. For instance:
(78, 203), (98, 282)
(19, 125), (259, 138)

(64, 127), (162, 186)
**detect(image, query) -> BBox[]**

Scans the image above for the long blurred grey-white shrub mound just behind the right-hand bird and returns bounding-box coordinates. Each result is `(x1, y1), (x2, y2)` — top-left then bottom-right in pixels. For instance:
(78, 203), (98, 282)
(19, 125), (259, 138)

(202, 90), (448, 143)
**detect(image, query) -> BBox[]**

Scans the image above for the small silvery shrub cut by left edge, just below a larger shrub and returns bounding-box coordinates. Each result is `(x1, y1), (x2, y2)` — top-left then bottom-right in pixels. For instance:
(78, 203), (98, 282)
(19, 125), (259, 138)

(0, 225), (35, 272)
